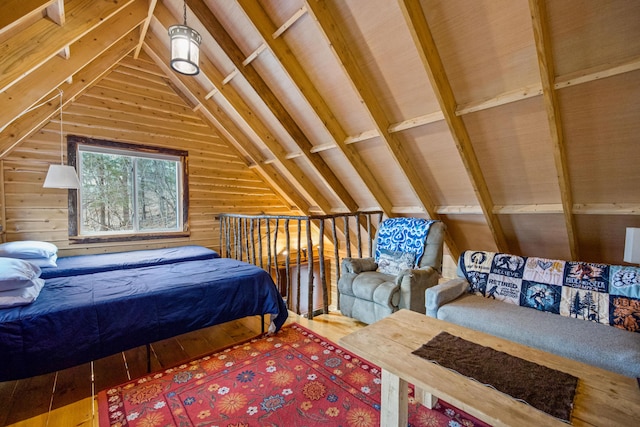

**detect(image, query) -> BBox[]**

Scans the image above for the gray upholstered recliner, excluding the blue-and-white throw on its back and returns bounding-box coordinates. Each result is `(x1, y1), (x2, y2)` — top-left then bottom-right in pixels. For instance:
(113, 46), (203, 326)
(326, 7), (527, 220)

(338, 221), (445, 323)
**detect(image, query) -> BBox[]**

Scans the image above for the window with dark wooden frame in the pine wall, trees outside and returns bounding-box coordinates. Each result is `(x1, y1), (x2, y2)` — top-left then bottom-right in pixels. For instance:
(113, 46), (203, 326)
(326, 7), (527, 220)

(68, 136), (187, 240)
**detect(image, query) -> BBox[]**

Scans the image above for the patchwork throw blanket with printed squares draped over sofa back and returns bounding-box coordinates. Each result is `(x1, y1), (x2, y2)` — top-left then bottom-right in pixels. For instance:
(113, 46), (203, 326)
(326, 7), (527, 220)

(460, 251), (640, 332)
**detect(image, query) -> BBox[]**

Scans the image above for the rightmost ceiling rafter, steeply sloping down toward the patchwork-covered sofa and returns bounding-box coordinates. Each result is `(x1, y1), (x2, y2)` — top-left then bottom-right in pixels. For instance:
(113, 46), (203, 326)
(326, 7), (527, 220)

(529, 0), (580, 260)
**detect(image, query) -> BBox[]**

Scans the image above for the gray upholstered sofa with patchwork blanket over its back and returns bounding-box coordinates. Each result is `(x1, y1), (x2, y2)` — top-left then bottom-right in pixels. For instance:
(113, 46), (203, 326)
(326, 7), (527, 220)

(425, 251), (640, 378)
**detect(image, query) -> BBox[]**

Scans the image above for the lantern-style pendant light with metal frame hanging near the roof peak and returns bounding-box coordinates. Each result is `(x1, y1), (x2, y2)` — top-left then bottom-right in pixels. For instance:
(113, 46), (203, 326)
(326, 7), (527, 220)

(169, 0), (202, 76)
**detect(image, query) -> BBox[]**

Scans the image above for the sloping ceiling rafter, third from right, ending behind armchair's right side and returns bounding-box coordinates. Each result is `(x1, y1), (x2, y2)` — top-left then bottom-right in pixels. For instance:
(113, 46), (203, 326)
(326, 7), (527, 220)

(305, 0), (459, 258)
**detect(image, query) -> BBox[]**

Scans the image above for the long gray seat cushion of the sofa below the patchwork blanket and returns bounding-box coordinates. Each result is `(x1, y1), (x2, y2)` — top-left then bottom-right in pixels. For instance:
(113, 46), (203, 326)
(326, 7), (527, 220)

(437, 294), (640, 377)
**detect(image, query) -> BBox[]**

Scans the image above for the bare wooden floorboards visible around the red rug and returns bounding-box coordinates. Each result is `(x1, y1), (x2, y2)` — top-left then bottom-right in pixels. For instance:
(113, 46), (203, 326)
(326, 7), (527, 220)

(0, 313), (364, 427)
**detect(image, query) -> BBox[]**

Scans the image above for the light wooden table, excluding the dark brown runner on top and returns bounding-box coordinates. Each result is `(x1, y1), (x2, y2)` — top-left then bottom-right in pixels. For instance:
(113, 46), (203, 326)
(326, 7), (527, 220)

(340, 310), (640, 427)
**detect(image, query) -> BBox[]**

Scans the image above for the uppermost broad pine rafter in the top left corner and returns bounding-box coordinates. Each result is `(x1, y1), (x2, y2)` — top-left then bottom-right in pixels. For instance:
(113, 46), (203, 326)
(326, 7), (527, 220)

(0, 0), (136, 91)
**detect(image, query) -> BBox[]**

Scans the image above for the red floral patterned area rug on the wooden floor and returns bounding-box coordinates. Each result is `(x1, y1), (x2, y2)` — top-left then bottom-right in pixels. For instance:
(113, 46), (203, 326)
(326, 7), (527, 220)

(98, 324), (486, 427)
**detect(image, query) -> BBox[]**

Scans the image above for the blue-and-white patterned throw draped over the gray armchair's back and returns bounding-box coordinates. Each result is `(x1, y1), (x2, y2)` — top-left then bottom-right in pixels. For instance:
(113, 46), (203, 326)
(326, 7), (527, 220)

(375, 218), (435, 267)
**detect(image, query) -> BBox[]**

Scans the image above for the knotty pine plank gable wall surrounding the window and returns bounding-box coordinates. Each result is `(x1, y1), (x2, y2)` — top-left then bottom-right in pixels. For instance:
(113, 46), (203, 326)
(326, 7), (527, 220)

(0, 51), (298, 256)
